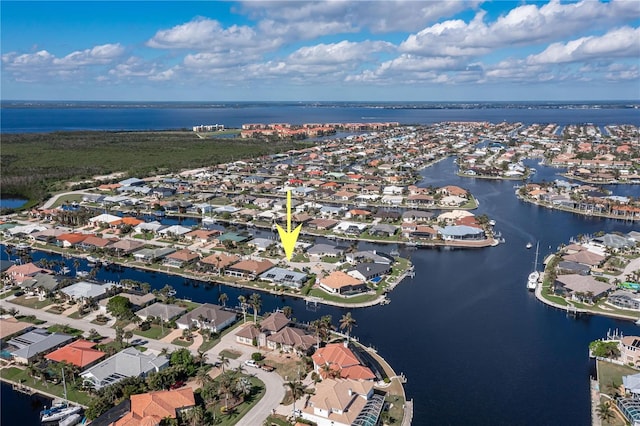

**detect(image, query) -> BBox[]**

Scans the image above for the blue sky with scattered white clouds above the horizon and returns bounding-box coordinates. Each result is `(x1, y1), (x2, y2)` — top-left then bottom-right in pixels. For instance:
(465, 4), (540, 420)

(0, 0), (640, 101)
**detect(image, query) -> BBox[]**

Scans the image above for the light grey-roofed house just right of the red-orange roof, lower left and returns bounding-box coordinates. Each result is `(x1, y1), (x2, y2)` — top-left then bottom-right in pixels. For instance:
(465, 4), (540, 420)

(80, 347), (169, 390)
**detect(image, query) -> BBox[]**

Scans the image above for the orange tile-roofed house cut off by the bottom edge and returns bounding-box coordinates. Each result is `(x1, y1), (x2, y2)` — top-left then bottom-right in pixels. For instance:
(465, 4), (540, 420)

(112, 387), (196, 426)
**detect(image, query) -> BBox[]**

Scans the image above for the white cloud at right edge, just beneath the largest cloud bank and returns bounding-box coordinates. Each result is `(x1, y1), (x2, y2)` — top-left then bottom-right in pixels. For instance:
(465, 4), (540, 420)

(527, 27), (640, 64)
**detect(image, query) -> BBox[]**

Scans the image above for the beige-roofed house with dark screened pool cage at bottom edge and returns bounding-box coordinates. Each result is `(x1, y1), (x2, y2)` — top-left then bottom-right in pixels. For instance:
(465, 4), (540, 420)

(301, 379), (384, 426)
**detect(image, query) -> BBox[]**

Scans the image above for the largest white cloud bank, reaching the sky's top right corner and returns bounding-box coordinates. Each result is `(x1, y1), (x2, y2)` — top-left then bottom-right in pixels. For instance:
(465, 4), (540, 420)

(400, 0), (640, 56)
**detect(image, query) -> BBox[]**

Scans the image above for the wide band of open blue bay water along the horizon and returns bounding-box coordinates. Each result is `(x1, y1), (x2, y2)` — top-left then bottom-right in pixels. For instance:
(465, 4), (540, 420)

(0, 101), (640, 133)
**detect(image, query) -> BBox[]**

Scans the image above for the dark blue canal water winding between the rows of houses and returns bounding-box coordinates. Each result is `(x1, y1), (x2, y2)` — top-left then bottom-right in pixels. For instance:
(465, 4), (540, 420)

(1, 158), (640, 425)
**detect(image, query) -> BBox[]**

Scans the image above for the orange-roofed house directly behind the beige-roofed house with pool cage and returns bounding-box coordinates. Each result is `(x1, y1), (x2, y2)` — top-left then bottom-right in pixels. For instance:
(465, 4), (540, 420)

(311, 342), (376, 380)
